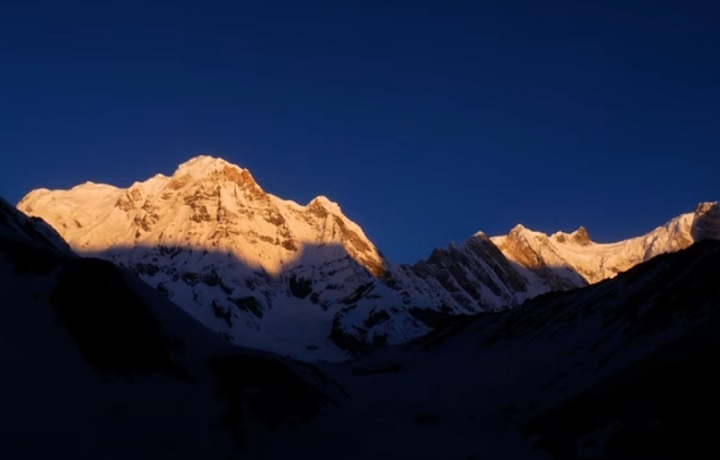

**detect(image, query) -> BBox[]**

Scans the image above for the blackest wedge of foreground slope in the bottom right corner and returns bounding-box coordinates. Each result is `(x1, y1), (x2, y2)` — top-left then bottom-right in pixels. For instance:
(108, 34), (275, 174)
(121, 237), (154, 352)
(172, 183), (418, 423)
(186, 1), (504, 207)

(527, 328), (720, 460)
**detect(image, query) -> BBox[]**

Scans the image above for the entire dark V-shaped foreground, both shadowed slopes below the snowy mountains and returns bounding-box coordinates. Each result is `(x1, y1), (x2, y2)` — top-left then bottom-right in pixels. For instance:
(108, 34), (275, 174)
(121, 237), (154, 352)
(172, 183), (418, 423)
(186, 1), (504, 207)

(0, 185), (720, 460)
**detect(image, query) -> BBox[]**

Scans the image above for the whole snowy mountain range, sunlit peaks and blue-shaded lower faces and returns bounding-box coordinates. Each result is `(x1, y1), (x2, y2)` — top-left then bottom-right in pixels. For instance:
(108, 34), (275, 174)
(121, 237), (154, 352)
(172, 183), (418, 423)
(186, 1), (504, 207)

(18, 156), (720, 360)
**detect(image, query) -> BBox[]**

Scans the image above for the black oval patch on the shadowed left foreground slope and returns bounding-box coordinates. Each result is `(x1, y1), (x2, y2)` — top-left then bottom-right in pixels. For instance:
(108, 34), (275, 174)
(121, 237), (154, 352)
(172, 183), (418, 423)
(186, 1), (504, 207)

(50, 258), (194, 382)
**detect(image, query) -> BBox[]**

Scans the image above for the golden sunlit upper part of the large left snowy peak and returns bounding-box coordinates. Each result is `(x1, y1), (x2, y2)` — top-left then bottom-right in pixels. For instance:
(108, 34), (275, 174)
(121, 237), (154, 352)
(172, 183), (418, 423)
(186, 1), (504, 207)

(18, 155), (384, 275)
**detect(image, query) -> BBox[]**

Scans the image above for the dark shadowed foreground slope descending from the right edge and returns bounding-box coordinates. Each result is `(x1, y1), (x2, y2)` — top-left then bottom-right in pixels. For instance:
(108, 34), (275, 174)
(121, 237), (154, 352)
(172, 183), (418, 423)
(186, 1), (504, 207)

(302, 237), (720, 460)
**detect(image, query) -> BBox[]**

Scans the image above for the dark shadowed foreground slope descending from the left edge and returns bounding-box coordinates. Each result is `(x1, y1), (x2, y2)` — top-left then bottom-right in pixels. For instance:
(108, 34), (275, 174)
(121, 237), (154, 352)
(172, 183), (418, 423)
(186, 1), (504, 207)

(0, 198), (345, 459)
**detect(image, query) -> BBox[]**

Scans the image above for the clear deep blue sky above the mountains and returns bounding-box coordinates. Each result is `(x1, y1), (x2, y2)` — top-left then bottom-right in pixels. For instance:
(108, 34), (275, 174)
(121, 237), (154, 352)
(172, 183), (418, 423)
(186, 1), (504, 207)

(0, 0), (720, 262)
